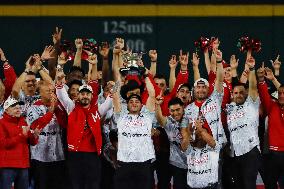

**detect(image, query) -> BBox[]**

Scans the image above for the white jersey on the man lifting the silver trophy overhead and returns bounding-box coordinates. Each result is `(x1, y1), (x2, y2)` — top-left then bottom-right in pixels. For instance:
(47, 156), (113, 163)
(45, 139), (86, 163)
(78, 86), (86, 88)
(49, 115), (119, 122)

(115, 108), (155, 162)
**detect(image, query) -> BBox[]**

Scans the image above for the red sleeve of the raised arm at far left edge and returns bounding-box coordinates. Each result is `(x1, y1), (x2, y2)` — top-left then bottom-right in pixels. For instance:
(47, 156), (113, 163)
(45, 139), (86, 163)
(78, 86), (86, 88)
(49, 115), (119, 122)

(3, 63), (17, 99)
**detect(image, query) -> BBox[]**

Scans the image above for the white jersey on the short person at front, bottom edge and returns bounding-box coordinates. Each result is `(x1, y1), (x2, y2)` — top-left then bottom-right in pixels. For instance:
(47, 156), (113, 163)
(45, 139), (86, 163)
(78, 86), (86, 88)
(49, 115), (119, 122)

(186, 145), (220, 188)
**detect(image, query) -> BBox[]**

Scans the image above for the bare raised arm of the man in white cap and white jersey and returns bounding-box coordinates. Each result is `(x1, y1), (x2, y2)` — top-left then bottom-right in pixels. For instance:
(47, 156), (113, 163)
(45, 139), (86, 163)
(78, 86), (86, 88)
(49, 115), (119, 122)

(215, 50), (224, 93)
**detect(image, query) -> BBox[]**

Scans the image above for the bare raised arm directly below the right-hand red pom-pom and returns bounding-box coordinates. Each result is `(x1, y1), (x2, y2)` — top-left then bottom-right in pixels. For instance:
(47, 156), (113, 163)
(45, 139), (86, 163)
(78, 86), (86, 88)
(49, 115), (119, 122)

(246, 56), (258, 101)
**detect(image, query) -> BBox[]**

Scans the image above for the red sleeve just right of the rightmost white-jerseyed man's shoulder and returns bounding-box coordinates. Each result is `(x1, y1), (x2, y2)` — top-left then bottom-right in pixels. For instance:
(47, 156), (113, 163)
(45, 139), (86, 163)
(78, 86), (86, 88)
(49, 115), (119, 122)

(257, 82), (273, 113)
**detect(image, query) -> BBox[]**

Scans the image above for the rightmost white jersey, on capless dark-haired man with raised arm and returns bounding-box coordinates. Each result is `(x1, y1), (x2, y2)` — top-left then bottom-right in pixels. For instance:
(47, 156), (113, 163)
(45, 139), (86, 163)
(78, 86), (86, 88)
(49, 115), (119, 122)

(227, 96), (260, 156)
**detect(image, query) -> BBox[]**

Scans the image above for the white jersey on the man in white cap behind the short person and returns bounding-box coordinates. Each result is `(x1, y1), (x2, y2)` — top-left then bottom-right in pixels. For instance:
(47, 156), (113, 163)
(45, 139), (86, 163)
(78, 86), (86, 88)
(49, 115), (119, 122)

(182, 89), (227, 146)
